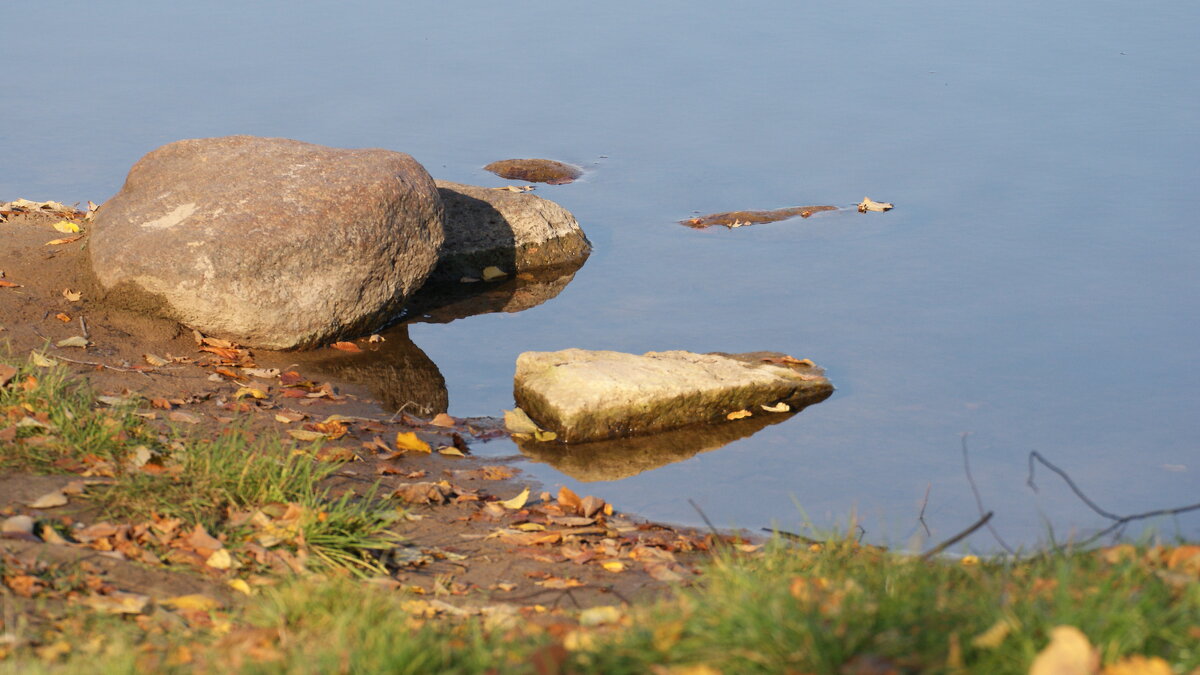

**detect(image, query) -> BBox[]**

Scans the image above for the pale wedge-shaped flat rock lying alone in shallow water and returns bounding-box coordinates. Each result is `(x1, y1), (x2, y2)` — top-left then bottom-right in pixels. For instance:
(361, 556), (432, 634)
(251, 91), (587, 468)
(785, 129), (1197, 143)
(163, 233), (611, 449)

(514, 350), (833, 443)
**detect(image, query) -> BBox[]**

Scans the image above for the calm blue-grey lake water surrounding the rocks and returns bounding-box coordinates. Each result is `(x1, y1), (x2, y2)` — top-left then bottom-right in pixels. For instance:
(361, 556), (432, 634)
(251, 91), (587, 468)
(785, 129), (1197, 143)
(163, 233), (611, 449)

(0, 0), (1200, 550)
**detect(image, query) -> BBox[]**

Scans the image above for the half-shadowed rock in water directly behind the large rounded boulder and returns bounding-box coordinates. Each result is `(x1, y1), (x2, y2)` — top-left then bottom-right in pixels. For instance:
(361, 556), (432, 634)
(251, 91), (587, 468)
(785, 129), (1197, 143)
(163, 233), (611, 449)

(431, 180), (592, 282)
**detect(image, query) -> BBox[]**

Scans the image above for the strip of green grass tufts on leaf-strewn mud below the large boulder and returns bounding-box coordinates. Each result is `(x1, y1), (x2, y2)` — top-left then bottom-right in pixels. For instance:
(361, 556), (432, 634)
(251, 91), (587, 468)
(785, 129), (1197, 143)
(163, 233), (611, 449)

(0, 353), (401, 573)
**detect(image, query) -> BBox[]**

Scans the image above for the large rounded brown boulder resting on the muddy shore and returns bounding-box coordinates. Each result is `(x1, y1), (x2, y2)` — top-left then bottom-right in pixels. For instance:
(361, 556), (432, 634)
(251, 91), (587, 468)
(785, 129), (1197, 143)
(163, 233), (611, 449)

(88, 136), (443, 350)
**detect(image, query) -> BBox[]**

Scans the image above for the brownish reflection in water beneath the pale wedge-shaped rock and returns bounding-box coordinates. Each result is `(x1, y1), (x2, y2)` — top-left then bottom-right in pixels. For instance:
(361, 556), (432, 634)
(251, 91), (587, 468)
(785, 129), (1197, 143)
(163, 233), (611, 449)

(517, 413), (796, 483)
